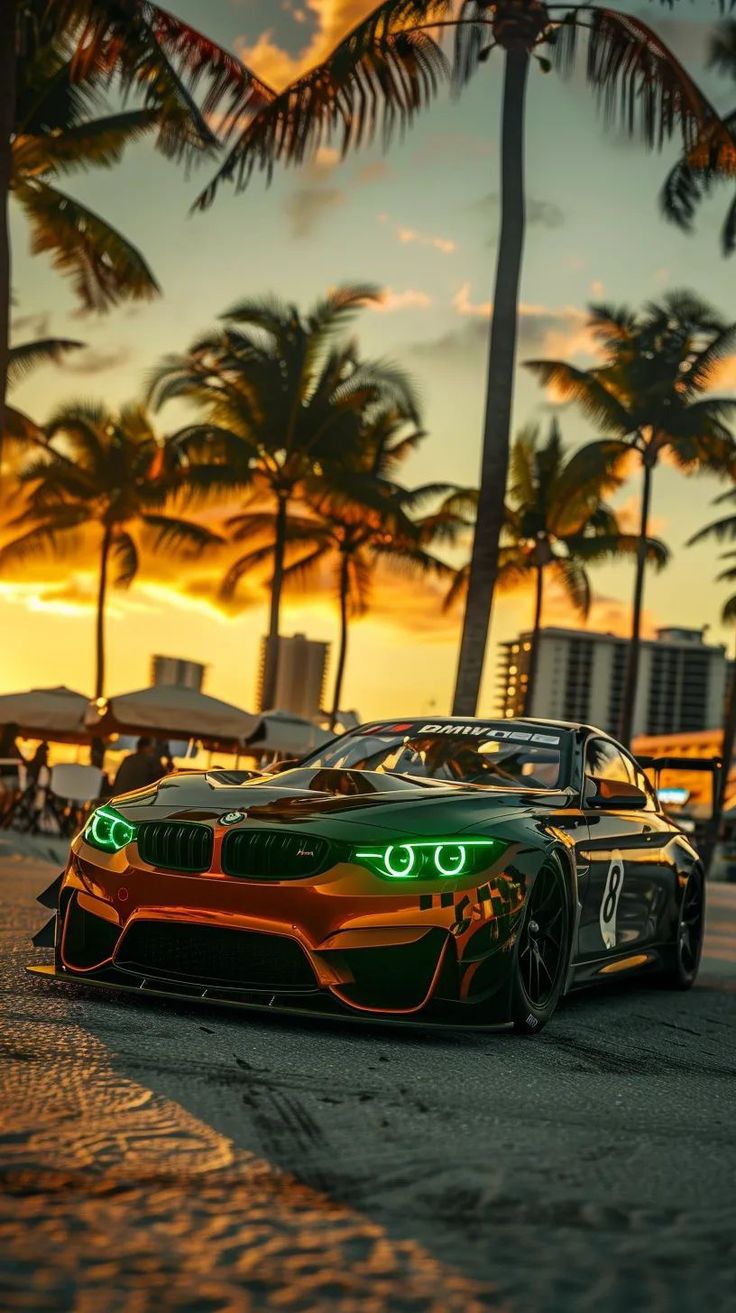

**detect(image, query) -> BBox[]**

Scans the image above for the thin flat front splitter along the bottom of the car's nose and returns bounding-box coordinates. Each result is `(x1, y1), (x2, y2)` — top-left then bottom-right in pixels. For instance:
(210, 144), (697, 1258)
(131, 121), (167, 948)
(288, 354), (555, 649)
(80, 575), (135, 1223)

(25, 965), (512, 1035)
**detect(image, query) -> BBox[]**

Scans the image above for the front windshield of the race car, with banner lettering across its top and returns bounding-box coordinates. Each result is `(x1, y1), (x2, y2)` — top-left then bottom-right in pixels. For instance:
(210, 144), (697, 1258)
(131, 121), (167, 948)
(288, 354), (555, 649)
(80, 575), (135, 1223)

(304, 723), (562, 789)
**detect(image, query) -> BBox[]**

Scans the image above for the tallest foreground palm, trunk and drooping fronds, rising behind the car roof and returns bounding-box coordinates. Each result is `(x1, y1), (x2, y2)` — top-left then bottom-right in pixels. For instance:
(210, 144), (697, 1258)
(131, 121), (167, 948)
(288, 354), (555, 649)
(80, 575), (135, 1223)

(192, 0), (719, 716)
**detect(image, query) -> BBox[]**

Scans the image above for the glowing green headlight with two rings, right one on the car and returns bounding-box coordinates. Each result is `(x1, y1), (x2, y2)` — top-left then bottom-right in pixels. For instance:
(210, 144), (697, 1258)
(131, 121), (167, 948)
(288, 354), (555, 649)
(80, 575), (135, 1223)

(353, 836), (506, 880)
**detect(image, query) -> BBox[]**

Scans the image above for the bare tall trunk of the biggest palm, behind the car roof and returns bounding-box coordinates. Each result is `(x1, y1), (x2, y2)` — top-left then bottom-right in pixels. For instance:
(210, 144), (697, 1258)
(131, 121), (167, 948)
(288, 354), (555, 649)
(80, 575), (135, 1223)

(453, 49), (529, 716)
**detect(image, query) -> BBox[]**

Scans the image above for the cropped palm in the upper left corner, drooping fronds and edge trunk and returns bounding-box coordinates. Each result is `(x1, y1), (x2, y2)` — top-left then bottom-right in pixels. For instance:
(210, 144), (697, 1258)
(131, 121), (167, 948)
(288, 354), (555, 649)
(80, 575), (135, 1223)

(0, 0), (272, 462)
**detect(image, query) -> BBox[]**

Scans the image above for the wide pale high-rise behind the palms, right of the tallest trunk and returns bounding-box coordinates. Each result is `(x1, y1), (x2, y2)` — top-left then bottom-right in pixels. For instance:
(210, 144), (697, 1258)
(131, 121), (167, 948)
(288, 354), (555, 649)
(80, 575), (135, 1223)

(499, 628), (727, 734)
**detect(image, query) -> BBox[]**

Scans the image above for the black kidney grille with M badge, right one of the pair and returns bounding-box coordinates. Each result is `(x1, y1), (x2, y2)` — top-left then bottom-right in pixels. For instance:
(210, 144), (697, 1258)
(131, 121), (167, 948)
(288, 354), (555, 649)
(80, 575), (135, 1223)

(222, 830), (336, 880)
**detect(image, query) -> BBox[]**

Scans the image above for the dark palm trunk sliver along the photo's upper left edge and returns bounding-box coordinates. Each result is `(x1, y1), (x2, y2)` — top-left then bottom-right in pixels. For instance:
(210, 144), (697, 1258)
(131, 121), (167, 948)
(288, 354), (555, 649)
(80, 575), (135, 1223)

(0, 0), (17, 493)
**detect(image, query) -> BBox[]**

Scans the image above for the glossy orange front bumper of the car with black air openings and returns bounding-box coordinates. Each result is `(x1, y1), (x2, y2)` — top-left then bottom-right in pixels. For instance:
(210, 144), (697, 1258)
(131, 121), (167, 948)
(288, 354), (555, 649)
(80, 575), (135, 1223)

(35, 842), (525, 1025)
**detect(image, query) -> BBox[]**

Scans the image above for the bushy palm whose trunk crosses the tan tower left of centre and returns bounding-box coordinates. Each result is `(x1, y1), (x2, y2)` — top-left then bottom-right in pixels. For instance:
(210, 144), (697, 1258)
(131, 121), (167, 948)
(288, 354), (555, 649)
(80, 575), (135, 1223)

(151, 286), (419, 708)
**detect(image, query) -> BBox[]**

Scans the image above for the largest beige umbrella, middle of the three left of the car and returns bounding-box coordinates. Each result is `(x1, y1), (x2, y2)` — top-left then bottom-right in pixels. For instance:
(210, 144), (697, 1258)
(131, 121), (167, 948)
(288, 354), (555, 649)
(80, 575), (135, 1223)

(87, 684), (260, 750)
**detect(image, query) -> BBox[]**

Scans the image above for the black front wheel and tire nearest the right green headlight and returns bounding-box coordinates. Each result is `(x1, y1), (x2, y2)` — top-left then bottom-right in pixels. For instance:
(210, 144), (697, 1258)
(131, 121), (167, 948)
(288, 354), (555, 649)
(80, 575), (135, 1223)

(510, 857), (572, 1035)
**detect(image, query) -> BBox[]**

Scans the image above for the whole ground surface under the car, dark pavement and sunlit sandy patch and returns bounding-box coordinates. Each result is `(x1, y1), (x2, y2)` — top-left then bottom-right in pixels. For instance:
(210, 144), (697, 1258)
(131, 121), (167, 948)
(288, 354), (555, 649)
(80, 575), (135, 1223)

(0, 860), (736, 1313)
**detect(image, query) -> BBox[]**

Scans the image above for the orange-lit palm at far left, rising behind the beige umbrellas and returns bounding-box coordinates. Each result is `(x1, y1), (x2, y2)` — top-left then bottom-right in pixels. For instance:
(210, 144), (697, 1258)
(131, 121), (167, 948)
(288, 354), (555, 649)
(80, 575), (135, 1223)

(0, 402), (222, 697)
